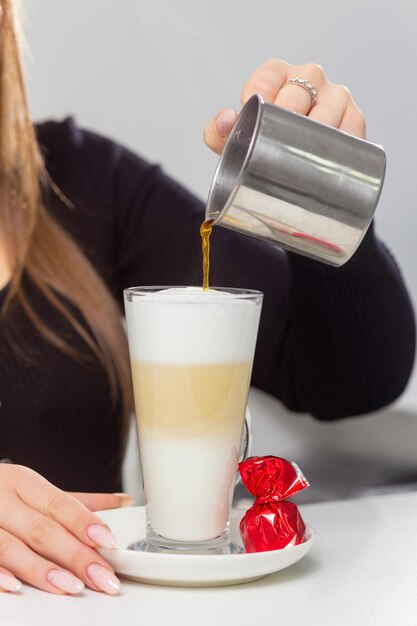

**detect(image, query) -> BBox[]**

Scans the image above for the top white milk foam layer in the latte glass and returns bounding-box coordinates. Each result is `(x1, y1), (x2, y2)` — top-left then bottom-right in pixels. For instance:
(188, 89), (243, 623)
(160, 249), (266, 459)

(126, 287), (261, 364)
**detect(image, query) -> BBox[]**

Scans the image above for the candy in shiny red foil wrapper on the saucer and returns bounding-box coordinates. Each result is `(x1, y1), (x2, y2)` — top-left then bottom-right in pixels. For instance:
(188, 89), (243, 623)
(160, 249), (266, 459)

(239, 456), (309, 552)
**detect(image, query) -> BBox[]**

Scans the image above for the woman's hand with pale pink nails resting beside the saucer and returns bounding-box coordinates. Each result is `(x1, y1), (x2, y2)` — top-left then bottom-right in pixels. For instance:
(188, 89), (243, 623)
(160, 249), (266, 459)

(0, 464), (130, 594)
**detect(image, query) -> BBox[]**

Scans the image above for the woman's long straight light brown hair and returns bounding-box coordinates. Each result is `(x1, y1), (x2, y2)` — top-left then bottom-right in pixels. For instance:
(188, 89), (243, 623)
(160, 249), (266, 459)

(0, 0), (132, 434)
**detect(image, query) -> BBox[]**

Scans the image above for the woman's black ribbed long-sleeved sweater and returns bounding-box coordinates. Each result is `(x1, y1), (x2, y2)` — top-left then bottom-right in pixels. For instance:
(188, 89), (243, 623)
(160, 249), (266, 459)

(0, 120), (415, 491)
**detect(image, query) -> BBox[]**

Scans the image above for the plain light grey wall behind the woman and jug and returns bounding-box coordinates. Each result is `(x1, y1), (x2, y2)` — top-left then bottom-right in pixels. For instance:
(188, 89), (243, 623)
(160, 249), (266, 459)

(23, 0), (417, 411)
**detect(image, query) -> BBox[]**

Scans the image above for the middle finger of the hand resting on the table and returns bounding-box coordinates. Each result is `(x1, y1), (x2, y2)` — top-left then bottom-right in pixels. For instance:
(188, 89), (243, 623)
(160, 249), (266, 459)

(1, 498), (120, 594)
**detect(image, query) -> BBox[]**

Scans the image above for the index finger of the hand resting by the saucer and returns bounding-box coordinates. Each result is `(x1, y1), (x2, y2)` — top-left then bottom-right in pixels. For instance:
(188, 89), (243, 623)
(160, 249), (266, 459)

(13, 468), (116, 548)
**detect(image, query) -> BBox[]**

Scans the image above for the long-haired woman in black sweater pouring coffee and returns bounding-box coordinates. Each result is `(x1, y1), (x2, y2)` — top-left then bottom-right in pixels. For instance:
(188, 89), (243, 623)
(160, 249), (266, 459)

(0, 0), (414, 594)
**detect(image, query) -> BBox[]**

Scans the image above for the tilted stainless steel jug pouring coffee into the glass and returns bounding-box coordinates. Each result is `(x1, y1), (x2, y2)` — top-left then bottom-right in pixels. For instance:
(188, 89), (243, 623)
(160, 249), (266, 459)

(206, 95), (386, 266)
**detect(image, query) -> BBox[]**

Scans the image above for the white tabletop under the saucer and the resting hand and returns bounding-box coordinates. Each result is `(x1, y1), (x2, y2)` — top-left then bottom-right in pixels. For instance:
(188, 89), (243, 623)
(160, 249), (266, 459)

(0, 492), (417, 626)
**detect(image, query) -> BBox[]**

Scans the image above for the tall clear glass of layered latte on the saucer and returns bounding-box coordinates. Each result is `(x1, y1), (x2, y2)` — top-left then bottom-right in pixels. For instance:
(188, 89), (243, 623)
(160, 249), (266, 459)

(124, 287), (263, 553)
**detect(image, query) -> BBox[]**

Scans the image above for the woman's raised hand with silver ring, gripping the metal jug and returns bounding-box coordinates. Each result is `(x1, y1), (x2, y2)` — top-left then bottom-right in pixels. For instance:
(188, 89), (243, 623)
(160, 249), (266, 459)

(204, 59), (366, 154)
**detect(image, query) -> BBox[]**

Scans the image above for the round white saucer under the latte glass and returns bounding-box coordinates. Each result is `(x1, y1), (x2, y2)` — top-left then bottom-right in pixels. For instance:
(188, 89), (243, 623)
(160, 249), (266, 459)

(98, 506), (314, 587)
